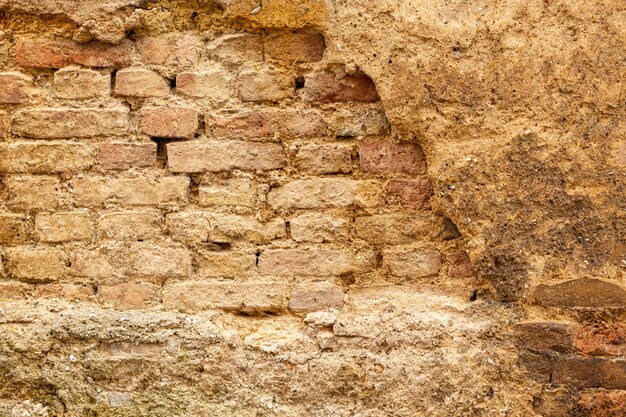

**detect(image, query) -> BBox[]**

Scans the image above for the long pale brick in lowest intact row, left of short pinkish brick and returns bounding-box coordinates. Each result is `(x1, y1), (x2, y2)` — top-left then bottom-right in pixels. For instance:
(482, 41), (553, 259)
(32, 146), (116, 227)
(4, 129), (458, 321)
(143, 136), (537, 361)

(163, 281), (287, 314)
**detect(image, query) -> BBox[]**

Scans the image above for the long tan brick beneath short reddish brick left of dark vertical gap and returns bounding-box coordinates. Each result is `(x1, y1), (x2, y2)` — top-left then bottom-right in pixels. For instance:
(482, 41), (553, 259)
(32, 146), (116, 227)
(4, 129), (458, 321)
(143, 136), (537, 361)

(71, 177), (189, 207)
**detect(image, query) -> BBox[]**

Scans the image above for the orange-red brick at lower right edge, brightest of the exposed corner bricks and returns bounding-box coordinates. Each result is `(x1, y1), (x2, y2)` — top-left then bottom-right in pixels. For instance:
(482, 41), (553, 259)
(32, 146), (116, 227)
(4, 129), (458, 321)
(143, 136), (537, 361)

(575, 323), (626, 357)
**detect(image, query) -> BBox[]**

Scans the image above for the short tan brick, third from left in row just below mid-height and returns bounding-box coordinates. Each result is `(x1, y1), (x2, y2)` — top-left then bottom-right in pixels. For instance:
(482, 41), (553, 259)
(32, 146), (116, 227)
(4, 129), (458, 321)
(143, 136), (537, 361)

(98, 211), (161, 240)
